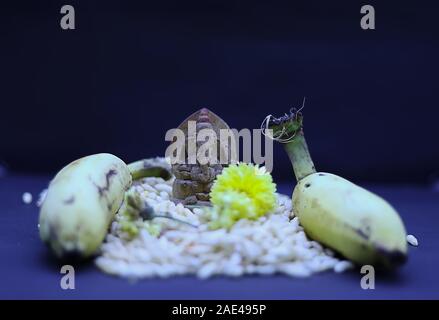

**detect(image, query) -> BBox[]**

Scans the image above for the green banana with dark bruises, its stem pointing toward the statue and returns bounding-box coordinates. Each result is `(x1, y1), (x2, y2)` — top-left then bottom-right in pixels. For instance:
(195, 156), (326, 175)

(39, 153), (171, 258)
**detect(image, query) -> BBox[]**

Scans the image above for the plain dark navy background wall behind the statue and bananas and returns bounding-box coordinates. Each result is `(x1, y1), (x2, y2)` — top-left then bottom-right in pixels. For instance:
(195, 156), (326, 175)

(0, 0), (439, 183)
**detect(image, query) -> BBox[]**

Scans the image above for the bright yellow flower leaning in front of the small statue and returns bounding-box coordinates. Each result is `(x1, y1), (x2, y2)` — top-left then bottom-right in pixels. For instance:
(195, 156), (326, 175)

(210, 163), (276, 228)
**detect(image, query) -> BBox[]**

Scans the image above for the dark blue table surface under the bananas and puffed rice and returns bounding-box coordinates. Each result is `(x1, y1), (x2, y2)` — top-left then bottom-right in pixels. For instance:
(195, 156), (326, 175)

(0, 175), (439, 299)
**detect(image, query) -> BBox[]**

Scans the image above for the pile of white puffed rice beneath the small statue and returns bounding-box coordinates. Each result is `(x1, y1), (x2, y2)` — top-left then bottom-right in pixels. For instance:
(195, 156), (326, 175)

(96, 166), (352, 279)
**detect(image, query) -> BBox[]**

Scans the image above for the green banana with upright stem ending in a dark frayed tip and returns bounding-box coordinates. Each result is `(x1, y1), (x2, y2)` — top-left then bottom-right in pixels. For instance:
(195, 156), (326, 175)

(267, 109), (407, 269)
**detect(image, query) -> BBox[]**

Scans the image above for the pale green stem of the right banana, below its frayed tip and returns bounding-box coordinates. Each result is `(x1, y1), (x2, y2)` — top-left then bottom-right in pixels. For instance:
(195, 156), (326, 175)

(284, 130), (316, 181)
